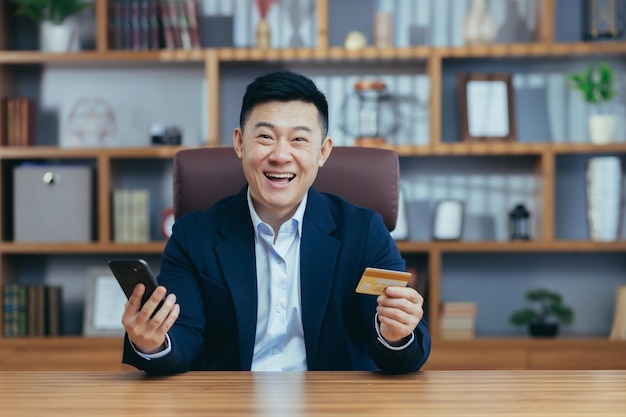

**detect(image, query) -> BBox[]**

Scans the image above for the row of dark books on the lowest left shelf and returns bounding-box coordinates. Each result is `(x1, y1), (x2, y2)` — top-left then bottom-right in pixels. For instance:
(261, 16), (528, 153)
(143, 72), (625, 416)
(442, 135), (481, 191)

(2, 284), (63, 338)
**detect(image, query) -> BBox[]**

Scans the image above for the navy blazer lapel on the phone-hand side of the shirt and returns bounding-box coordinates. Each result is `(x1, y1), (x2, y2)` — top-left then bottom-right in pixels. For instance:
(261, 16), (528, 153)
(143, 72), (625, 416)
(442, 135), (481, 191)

(216, 187), (257, 370)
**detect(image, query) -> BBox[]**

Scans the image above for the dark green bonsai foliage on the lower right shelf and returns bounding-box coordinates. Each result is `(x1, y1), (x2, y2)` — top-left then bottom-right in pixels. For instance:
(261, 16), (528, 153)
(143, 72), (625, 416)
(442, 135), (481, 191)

(509, 288), (574, 326)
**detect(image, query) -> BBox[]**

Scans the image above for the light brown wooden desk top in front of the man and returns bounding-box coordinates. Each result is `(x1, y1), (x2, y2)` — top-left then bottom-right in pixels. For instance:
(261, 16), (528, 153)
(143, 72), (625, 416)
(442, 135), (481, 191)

(0, 371), (626, 417)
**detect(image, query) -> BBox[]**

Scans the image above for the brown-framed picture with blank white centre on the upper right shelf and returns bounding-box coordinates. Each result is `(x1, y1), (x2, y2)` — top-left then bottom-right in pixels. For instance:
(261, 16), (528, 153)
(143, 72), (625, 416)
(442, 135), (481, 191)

(457, 73), (517, 142)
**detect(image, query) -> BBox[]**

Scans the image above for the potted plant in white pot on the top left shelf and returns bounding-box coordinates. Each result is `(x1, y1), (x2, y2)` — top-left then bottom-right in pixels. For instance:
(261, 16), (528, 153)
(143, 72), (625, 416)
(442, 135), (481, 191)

(11, 0), (91, 52)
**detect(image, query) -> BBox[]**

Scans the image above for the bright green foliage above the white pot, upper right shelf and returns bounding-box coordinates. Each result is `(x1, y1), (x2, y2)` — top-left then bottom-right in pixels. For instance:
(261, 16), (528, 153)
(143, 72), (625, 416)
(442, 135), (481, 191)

(568, 62), (615, 111)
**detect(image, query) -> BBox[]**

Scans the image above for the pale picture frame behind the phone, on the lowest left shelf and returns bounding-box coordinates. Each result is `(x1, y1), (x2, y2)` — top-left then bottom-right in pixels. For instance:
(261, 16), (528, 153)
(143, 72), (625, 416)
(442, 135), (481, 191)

(83, 268), (126, 337)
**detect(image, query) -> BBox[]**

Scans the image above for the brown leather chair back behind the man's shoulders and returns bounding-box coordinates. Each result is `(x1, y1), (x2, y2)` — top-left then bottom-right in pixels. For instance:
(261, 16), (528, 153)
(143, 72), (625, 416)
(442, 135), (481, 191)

(174, 146), (400, 231)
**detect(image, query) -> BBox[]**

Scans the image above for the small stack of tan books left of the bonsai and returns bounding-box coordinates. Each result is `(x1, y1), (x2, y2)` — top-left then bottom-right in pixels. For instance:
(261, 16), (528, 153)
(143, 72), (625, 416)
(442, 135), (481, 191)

(439, 301), (478, 339)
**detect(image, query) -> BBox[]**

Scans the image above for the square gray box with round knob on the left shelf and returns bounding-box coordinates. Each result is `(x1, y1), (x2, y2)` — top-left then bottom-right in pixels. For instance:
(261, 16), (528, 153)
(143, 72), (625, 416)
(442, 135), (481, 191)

(13, 165), (93, 242)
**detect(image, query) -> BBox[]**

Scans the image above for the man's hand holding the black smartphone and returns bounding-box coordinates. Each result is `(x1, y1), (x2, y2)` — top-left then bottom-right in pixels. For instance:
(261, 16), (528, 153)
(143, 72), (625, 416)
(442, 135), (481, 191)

(122, 284), (180, 354)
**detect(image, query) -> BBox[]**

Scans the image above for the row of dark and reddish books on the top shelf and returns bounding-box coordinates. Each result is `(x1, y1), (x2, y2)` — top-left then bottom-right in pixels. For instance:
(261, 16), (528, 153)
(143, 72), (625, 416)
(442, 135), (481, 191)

(108, 0), (200, 50)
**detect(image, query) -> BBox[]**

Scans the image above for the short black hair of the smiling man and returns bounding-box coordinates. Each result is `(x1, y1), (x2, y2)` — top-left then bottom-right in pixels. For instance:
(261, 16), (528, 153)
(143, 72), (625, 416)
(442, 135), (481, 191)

(239, 70), (328, 139)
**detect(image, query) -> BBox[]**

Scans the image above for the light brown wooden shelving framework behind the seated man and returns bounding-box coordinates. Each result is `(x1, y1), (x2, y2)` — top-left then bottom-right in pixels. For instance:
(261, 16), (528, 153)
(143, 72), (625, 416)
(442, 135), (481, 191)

(0, 0), (626, 370)
